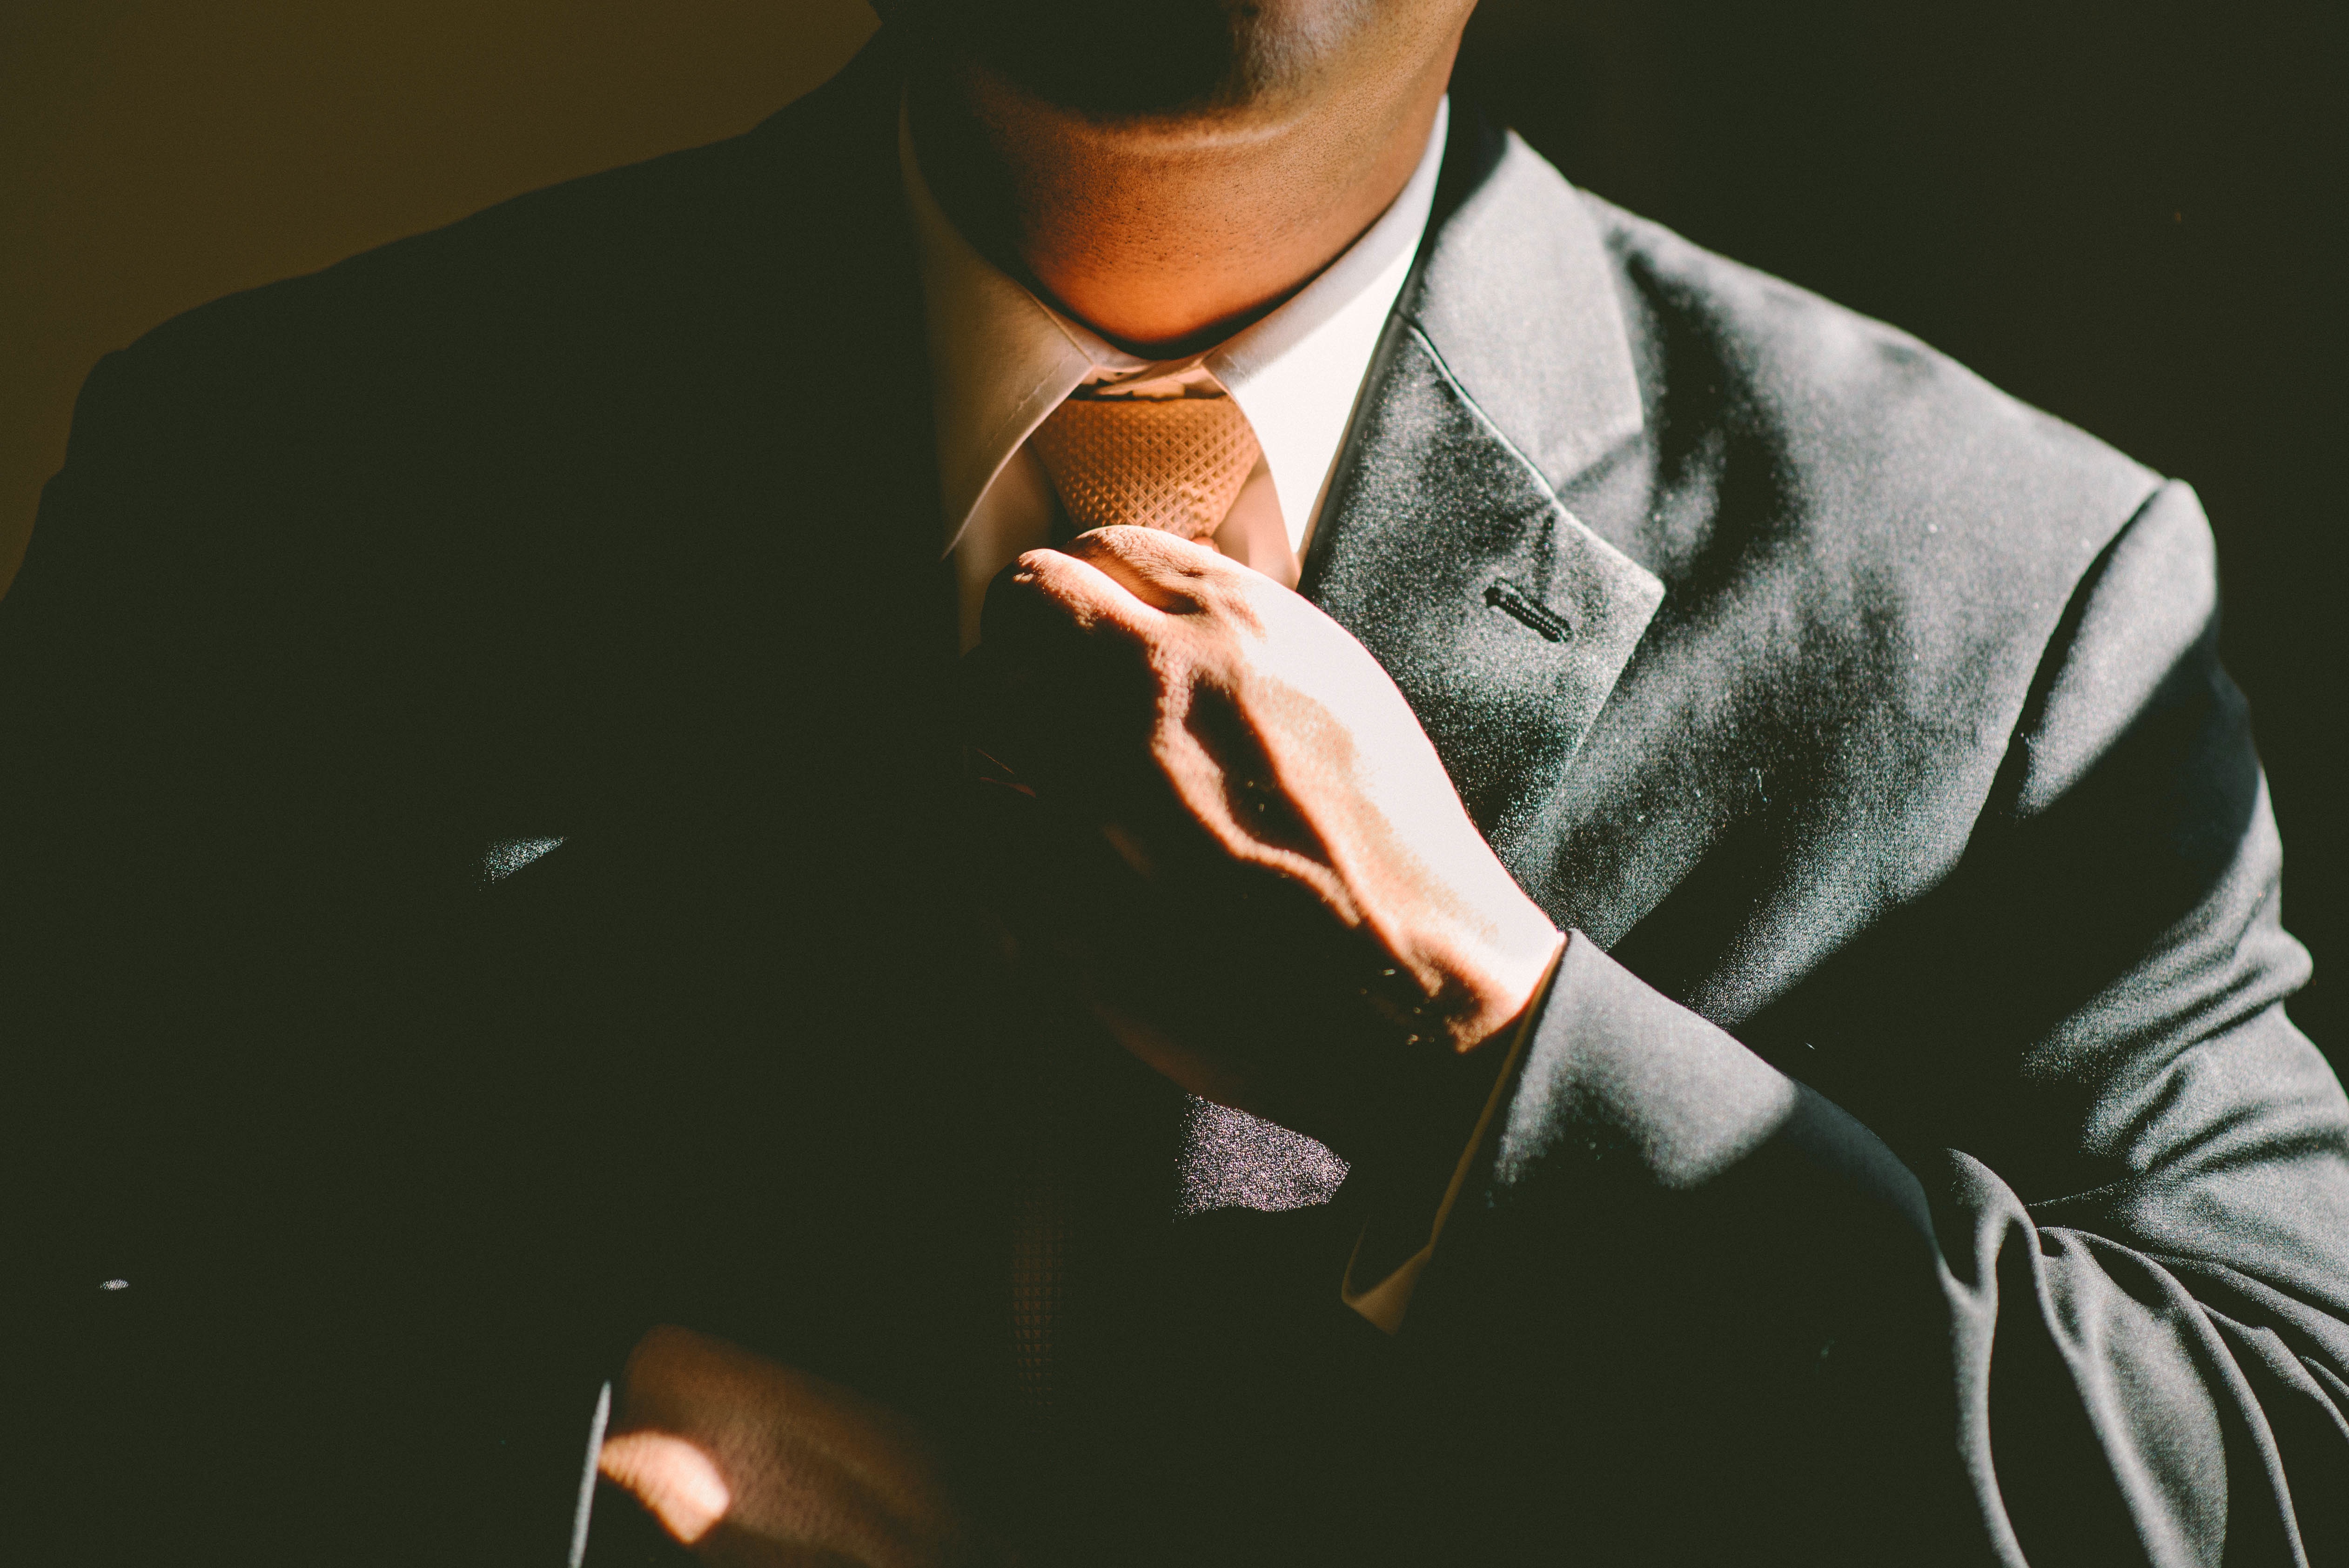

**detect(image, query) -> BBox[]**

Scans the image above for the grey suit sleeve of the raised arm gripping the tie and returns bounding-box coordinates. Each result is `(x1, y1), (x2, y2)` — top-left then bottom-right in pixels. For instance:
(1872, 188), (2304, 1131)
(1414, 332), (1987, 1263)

(1405, 486), (2349, 1566)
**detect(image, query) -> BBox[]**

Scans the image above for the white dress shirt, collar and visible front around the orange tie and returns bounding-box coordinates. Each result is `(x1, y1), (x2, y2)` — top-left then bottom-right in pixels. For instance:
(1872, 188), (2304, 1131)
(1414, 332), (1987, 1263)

(897, 99), (1452, 650)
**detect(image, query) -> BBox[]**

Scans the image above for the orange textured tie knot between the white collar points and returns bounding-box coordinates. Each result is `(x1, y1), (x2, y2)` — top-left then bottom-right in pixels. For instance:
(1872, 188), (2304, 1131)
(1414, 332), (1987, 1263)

(1029, 397), (1262, 540)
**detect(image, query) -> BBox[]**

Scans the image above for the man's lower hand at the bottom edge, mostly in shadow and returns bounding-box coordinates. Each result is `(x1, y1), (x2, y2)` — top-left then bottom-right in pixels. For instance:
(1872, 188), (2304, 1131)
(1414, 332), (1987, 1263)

(601, 1328), (1008, 1568)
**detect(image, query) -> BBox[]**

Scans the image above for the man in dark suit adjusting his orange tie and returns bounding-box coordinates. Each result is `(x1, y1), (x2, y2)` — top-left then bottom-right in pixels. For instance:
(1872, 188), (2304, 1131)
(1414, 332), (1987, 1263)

(0, 5), (2349, 1563)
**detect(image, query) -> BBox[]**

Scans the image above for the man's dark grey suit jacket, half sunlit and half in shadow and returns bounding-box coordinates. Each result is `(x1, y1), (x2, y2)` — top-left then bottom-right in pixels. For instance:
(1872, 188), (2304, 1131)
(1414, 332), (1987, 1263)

(0, 40), (2349, 1563)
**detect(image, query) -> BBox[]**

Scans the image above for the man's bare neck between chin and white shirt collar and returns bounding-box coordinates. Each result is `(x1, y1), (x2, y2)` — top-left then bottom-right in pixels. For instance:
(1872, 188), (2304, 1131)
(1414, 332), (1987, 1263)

(912, 38), (1456, 359)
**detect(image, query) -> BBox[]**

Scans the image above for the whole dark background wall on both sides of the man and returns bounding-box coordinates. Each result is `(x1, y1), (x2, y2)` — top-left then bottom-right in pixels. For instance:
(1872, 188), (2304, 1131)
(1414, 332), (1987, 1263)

(0, 0), (2349, 1061)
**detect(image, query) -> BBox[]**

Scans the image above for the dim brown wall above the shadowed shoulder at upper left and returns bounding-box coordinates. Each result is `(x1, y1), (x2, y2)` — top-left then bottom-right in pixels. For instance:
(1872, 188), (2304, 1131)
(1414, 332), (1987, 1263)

(0, 0), (874, 584)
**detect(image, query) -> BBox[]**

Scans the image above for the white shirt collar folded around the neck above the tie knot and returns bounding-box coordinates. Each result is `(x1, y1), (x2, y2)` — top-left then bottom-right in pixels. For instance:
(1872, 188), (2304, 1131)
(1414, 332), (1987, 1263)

(897, 99), (1452, 552)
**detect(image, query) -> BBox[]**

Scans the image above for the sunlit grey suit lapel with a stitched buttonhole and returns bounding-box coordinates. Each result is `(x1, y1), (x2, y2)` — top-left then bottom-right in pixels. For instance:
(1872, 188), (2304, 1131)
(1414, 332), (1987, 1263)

(1302, 115), (1663, 876)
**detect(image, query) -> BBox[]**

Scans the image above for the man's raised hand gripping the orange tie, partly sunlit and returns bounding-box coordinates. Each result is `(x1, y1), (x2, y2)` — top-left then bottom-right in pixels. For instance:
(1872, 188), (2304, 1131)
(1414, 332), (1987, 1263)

(973, 528), (1557, 1155)
